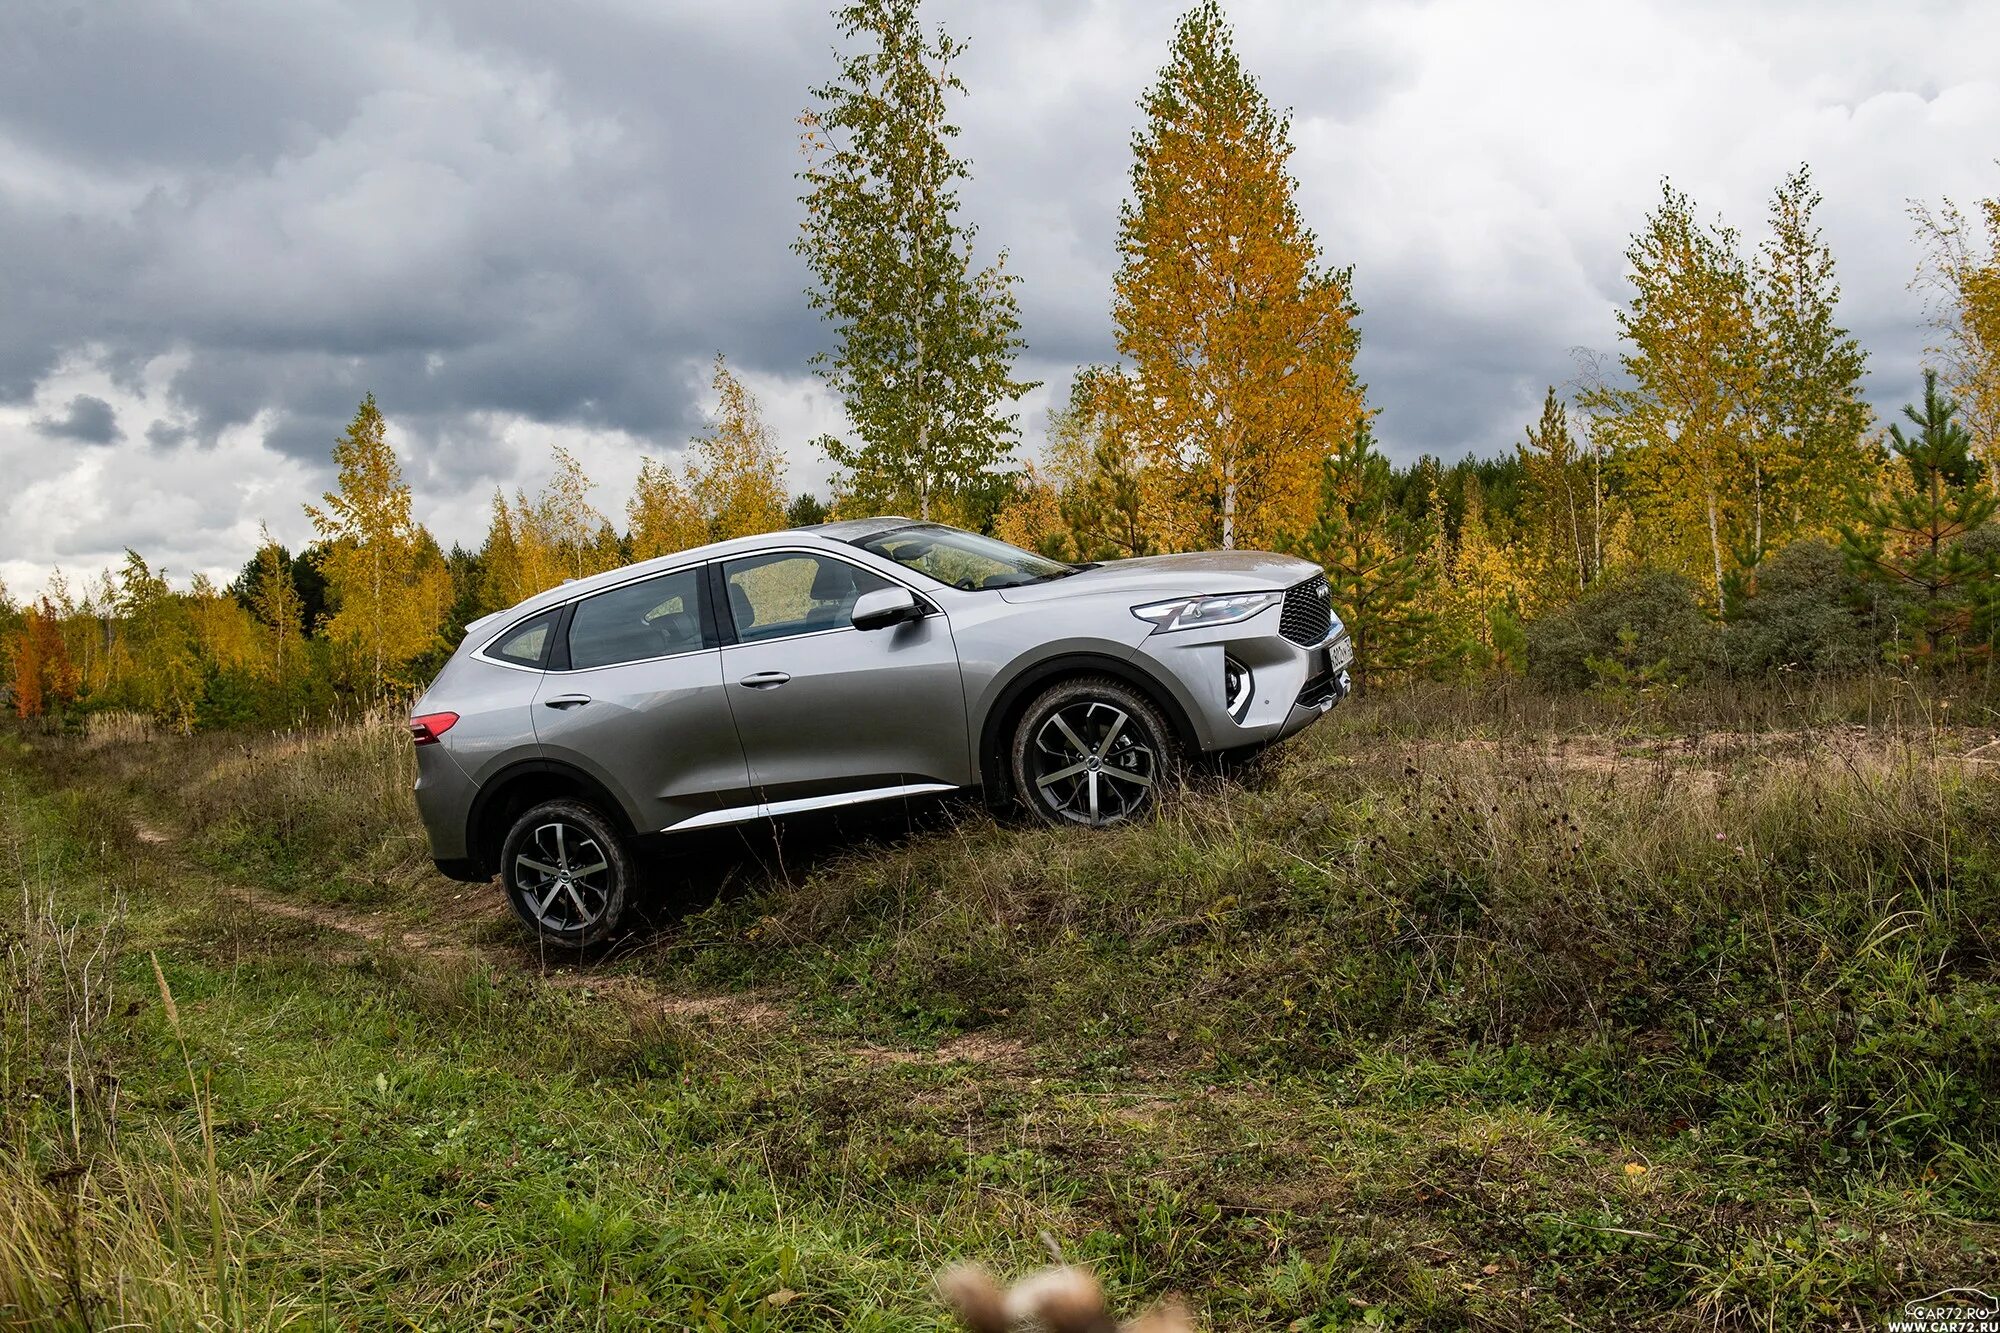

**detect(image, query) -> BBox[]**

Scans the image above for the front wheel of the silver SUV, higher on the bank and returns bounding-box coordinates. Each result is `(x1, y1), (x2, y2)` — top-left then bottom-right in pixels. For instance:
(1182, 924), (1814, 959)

(1010, 677), (1180, 829)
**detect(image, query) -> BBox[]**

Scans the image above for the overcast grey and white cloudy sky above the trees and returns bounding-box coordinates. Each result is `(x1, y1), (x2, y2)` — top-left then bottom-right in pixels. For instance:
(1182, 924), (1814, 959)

(0, 0), (2000, 596)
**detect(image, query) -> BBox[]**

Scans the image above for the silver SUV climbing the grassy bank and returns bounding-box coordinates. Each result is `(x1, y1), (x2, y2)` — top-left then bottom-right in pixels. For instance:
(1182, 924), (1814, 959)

(410, 518), (1352, 945)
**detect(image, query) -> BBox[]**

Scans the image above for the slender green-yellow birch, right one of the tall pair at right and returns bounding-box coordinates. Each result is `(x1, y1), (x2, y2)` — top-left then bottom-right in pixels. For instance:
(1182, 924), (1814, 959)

(1746, 166), (1876, 548)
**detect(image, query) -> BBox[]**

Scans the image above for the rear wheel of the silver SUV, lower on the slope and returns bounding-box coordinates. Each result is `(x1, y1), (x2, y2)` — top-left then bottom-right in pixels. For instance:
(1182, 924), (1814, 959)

(500, 801), (638, 949)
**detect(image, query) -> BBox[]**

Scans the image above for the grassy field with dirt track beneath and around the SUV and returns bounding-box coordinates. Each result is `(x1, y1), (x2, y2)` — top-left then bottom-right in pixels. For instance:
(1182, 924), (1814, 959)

(0, 681), (2000, 1331)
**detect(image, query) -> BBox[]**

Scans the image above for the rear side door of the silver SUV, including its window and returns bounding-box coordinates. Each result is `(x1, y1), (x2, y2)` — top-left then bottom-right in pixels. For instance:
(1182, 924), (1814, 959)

(534, 564), (750, 833)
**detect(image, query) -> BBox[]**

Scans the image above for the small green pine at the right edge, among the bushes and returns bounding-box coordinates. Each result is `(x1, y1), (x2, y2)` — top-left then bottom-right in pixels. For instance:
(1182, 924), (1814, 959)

(1842, 370), (2000, 667)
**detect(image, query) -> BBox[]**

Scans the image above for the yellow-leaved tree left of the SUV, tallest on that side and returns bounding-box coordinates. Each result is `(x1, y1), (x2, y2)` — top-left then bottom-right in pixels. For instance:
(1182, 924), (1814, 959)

(306, 394), (448, 699)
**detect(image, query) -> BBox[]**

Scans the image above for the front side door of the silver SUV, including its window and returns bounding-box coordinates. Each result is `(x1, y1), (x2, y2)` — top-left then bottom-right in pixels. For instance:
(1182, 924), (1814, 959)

(718, 550), (972, 807)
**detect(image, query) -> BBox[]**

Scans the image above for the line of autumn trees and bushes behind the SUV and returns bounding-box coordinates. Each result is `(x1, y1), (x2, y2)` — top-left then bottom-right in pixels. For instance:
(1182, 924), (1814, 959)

(0, 0), (2000, 729)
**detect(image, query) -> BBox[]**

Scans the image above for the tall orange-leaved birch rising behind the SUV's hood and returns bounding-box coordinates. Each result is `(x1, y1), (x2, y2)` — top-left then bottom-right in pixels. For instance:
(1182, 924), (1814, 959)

(1114, 0), (1362, 546)
